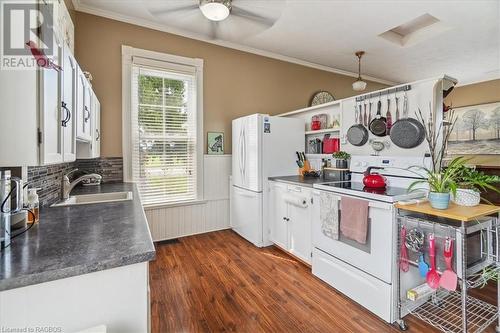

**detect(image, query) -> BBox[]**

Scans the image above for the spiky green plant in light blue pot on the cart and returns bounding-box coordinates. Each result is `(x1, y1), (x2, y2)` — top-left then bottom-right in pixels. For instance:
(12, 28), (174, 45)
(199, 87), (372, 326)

(408, 157), (466, 209)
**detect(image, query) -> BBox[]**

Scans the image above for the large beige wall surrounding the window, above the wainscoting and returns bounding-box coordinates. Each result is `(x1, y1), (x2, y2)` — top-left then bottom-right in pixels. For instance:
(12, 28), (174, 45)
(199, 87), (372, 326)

(75, 12), (383, 157)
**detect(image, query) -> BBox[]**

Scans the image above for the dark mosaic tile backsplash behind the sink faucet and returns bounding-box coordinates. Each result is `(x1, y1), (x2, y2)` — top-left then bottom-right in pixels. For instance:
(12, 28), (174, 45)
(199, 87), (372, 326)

(28, 157), (123, 207)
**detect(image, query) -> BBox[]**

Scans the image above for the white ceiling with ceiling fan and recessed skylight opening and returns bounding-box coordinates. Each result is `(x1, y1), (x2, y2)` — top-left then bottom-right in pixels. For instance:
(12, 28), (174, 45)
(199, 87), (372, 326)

(73, 0), (500, 85)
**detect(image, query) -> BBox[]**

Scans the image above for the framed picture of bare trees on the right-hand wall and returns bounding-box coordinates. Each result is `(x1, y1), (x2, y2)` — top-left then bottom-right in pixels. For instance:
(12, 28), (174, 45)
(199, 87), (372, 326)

(447, 102), (500, 155)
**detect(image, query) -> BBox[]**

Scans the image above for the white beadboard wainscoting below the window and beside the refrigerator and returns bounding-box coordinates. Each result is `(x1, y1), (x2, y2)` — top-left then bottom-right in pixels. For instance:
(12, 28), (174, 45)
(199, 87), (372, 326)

(146, 155), (231, 241)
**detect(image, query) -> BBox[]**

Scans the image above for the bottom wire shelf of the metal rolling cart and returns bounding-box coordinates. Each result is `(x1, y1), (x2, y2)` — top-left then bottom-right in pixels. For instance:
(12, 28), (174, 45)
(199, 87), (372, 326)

(411, 290), (498, 333)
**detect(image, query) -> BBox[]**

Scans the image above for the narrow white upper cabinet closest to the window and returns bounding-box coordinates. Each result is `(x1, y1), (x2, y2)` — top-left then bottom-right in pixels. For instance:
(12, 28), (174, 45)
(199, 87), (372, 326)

(77, 90), (101, 159)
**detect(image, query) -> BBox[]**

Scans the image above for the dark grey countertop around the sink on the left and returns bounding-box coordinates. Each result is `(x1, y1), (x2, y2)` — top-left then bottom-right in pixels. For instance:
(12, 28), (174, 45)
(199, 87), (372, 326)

(0, 183), (155, 291)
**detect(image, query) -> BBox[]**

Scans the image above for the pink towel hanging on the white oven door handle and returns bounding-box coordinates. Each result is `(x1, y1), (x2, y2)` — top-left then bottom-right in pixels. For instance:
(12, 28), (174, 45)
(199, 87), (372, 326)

(340, 197), (368, 244)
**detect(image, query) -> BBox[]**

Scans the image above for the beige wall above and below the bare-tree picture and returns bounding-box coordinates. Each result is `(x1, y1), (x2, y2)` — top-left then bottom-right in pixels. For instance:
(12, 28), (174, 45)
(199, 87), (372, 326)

(445, 80), (500, 167)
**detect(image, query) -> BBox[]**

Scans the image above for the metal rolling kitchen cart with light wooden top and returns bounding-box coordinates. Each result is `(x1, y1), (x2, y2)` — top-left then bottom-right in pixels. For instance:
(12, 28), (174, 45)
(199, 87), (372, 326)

(395, 202), (500, 333)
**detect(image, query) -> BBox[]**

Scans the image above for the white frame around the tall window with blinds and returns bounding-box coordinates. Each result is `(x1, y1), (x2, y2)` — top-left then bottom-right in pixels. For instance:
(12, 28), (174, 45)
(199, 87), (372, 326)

(122, 45), (204, 207)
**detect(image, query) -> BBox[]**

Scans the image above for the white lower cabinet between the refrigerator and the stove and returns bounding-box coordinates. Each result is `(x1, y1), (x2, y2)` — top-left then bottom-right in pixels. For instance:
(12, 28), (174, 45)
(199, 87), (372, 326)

(270, 182), (313, 263)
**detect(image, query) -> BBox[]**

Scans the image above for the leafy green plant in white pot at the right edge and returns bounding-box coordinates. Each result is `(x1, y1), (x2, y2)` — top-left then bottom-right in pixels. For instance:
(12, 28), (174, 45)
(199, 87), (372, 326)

(452, 165), (500, 206)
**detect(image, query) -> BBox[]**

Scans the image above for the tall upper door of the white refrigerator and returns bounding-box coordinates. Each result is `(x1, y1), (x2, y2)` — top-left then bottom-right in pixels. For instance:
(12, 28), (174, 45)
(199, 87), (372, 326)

(232, 114), (263, 192)
